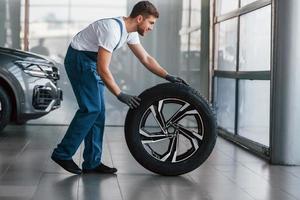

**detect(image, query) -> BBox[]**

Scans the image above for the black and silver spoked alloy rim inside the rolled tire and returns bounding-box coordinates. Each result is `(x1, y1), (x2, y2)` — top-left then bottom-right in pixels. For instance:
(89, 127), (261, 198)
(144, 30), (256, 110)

(139, 98), (205, 163)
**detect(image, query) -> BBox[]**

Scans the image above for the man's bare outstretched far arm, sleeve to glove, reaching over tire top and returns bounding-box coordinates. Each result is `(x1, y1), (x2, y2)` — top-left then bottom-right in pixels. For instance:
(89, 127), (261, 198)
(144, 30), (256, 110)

(128, 44), (168, 78)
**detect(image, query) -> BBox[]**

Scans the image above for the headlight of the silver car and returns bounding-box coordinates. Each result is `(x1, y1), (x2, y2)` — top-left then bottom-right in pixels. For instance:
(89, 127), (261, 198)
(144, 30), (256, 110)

(14, 60), (52, 78)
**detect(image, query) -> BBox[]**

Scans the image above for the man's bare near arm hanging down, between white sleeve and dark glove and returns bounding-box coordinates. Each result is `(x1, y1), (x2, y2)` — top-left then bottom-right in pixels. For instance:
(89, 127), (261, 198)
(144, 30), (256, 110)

(97, 47), (121, 96)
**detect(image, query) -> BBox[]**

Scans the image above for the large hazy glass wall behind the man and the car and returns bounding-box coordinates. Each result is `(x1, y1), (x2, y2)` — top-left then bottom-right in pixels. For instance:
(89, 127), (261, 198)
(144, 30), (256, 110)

(15, 0), (204, 125)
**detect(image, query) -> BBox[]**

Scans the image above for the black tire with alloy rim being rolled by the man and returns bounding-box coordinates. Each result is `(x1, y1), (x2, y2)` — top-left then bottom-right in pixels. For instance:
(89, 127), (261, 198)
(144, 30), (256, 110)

(125, 83), (217, 176)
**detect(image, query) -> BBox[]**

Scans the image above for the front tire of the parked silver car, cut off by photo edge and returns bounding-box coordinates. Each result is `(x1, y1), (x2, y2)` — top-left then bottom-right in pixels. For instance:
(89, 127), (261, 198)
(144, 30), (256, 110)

(0, 86), (11, 132)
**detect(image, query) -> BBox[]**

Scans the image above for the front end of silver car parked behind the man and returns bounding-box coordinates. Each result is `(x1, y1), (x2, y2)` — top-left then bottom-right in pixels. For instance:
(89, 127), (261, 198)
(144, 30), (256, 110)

(0, 47), (63, 131)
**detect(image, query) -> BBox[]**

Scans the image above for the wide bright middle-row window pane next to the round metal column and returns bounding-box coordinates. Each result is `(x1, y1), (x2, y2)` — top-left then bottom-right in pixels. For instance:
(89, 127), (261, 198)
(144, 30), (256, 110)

(239, 6), (271, 71)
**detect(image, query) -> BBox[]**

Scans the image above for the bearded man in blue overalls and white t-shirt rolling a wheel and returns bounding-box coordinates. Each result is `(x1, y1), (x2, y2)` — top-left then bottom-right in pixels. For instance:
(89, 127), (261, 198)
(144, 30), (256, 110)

(51, 1), (188, 174)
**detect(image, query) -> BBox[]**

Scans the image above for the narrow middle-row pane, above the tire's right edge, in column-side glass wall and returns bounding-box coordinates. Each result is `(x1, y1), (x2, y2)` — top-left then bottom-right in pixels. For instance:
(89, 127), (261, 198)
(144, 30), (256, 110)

(215, 18), (237, 71)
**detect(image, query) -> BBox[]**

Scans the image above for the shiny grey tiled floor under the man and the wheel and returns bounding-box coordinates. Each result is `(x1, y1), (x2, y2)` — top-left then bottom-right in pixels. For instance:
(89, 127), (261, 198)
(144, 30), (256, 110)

(0, 125), (300, 200)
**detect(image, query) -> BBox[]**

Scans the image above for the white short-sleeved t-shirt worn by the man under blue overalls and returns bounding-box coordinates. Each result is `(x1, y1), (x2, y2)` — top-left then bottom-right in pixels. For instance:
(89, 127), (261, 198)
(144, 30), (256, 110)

(71, 17), (140, 52)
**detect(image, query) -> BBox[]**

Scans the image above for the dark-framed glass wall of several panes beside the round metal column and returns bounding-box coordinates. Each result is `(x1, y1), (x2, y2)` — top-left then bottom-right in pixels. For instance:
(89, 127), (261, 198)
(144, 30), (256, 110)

(213, 0), (271, 147)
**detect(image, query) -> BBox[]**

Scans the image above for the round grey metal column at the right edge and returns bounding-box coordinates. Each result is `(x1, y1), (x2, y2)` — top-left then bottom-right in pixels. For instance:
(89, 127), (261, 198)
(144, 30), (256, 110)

(270, 0), (300, 165)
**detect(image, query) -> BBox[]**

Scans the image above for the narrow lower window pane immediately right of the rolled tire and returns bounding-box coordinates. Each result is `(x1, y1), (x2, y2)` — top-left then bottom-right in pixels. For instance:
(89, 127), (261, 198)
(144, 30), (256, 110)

(214, 78), (235, 133)
